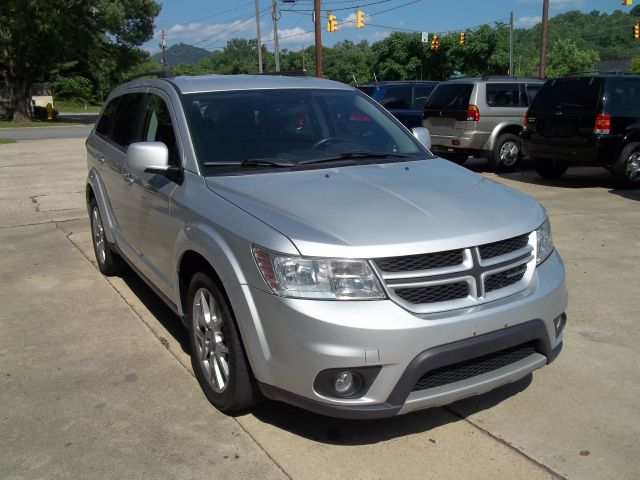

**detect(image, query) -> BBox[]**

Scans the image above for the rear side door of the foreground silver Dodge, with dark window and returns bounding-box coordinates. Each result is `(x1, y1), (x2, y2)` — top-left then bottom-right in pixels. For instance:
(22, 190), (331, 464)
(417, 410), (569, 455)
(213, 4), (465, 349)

(93, 93), (144, 258)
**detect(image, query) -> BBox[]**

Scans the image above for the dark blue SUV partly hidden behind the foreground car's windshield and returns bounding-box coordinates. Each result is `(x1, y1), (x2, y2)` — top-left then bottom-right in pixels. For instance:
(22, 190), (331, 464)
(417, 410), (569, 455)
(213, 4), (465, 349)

(356, 80), (438, 130)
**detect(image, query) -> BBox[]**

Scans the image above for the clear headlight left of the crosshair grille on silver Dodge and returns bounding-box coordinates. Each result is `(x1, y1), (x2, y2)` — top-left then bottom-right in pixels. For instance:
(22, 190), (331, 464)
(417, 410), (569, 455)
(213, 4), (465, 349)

(253, 247), (385, 300)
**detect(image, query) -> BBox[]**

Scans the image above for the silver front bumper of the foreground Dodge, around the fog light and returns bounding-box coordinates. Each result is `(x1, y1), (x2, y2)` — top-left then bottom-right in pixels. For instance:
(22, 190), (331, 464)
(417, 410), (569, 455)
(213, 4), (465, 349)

(227, 252), (567, 418)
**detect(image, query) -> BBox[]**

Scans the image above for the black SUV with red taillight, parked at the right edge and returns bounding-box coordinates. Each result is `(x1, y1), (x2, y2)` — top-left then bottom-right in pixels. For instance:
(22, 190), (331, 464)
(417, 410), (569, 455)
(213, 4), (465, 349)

(521, 75), (640, 188)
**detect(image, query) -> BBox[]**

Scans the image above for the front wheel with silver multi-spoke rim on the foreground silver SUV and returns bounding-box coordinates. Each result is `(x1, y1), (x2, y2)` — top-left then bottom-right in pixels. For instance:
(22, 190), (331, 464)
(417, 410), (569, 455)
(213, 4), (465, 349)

(186, 272), (260, 413)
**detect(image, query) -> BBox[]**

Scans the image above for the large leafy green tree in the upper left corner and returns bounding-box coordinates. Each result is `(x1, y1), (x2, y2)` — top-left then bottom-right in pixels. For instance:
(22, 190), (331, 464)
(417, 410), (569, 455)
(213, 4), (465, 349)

(0, 0), (160, 120)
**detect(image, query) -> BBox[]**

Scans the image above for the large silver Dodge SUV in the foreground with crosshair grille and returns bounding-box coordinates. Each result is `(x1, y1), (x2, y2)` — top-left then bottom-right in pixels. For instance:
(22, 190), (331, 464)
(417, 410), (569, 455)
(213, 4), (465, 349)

(86, 76), (567, 418)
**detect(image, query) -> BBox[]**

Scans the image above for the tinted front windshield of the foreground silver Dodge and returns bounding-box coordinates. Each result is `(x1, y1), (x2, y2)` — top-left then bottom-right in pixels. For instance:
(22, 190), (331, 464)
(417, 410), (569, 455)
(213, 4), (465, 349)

(183, 89), (428, 175)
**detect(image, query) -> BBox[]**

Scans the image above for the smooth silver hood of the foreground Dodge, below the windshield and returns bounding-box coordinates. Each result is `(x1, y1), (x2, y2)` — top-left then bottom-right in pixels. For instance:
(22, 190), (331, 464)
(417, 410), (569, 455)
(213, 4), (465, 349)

(206, 158), (545, 258)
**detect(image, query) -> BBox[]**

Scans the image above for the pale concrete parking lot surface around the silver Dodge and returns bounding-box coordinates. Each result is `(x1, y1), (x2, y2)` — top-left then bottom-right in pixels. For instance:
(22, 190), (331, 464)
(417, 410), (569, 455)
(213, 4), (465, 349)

(0, 138), (640, 479)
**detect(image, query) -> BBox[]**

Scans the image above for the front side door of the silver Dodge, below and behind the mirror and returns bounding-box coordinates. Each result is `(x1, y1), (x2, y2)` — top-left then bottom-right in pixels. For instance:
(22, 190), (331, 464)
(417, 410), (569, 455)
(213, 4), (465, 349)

(129, 89), (183, 298)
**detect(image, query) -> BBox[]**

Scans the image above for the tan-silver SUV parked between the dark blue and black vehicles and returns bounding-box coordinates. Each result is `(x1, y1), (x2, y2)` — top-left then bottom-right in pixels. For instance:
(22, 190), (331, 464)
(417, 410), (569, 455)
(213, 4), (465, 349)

(422, 76), (544, 172)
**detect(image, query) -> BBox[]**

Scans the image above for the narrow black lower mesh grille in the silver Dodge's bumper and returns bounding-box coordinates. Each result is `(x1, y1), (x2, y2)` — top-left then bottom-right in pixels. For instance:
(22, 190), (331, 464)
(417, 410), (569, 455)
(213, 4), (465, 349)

(413, 343), (536, 392)
